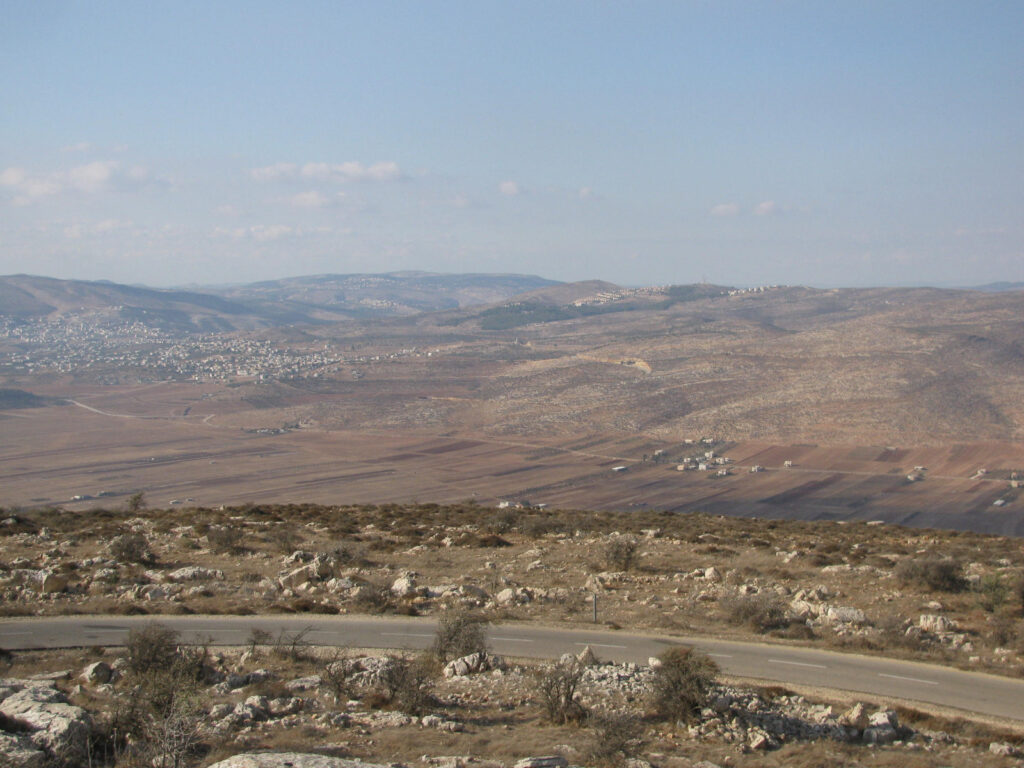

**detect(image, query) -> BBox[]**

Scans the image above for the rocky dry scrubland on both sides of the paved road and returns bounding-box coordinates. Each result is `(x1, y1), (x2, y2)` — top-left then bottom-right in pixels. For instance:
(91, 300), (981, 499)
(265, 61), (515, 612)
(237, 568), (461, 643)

(0, 505), (1024, 768)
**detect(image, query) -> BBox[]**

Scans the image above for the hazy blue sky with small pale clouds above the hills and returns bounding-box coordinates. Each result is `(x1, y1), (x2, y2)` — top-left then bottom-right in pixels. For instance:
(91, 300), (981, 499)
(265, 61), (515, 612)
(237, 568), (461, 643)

(0, 0), (1024, 286)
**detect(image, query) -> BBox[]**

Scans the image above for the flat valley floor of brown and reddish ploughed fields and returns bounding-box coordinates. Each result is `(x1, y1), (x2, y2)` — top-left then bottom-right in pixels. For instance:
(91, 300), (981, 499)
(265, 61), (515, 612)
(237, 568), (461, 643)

(0, 391), (1024, 536)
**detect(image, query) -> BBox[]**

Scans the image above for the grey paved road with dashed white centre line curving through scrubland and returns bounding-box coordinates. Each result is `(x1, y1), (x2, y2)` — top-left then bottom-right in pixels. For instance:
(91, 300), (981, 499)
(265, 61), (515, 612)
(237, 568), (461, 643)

(6, 615), (1024, 722)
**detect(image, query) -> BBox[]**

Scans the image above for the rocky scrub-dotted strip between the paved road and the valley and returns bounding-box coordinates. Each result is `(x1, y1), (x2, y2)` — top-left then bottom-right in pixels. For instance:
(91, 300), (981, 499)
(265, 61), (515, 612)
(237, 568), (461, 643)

(0, 505), (1024, 675)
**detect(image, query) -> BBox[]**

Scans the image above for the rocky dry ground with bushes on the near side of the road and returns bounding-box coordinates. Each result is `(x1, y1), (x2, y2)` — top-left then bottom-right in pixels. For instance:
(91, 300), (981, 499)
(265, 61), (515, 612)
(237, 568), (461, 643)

(0, 645), (1024, 768)
